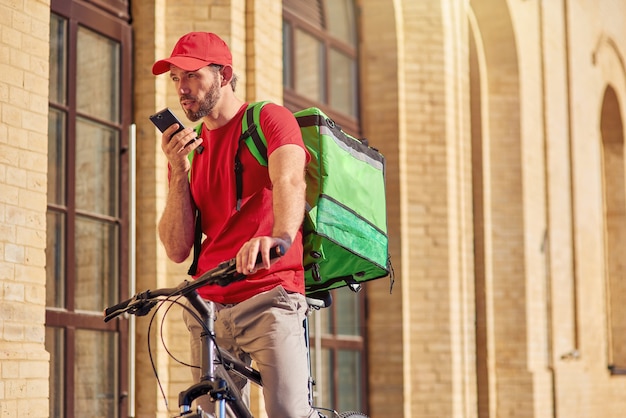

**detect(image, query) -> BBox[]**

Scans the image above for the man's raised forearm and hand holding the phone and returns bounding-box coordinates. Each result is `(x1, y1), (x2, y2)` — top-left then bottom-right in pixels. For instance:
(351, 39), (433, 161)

(159, 125), (202, 263)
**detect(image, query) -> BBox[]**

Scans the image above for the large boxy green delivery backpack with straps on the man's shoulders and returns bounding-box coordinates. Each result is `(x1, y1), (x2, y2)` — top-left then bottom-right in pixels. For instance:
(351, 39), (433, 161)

(190, 102), (393, 296)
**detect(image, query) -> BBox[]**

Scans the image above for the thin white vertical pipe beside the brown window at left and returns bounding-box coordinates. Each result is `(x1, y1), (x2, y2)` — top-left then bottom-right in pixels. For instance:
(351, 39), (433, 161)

(128, 123), (137, 418)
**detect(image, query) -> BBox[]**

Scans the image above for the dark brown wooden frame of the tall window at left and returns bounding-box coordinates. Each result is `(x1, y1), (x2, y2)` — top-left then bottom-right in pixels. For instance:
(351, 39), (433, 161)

(46, 0), (132, 417)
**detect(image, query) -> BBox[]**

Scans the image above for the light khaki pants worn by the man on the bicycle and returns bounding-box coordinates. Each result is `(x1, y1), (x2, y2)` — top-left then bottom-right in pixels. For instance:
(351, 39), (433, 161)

(183, 286), (318, 418)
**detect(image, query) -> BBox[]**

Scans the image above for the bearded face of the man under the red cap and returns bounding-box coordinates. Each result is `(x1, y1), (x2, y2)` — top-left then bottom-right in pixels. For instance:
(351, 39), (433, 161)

(170, 66), (222, 122)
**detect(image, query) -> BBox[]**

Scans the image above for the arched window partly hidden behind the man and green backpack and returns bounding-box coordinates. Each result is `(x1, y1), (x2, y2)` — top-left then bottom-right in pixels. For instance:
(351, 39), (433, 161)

(283, 0), (367, 411)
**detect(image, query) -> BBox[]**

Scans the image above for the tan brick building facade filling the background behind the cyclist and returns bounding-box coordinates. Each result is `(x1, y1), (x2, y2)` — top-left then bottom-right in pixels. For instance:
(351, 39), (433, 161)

(0, 0), (626, 418)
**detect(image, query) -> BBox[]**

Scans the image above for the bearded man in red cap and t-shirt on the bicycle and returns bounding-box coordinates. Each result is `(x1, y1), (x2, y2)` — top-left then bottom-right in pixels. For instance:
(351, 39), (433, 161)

(152, 32), (317, 418)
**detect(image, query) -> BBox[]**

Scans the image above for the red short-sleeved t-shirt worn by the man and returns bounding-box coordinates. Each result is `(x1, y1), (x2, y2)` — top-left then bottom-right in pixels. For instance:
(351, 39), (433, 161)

(186, 103), (308, 303)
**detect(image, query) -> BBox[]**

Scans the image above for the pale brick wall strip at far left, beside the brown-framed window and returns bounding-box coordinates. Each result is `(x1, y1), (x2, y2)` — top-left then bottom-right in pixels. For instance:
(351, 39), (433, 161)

(0, 0), (50, 417)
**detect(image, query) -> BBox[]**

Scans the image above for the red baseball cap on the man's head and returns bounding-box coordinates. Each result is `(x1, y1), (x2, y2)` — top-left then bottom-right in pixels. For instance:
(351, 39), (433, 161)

(152, 32), (233, 75)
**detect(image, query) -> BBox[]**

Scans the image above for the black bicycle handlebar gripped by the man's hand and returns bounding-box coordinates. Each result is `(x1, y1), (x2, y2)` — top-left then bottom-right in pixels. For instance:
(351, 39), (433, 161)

(104, 245), (285, 322)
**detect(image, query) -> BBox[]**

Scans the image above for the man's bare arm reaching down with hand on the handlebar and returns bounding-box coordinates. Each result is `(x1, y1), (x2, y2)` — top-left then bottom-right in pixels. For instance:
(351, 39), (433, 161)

(237, 144), (306, 274)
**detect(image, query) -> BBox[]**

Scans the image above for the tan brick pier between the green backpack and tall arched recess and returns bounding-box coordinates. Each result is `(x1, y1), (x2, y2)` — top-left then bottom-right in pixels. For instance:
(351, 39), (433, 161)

(361, 1), (475, 417)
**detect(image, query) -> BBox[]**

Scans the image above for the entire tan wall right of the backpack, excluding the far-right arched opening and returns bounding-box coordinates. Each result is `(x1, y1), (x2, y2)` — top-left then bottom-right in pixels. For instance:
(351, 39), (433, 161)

(360, 0), (626, 417)
